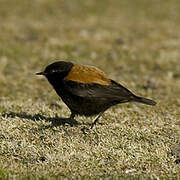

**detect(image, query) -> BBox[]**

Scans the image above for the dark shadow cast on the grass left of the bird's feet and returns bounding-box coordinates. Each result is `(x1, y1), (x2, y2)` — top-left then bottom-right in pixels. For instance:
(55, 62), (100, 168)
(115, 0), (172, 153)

(2, 111), (81, 126)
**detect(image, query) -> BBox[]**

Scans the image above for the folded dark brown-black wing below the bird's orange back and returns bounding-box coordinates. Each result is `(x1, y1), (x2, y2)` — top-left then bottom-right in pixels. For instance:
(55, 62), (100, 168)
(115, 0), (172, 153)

(63, 80), (132, 101)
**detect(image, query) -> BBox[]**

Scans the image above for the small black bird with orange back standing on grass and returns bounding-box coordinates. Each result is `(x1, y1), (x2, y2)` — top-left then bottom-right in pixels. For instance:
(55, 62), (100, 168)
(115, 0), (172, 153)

(36, 61), (156, 128)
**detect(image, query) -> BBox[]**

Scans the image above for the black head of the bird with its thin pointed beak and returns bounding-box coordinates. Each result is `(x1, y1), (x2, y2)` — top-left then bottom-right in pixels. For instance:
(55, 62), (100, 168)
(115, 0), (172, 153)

(36, 61), (73, 78)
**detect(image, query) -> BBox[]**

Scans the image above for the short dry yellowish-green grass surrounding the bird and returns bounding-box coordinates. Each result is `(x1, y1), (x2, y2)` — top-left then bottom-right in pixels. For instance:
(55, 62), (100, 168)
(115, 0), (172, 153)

(0, 0), (180, 179)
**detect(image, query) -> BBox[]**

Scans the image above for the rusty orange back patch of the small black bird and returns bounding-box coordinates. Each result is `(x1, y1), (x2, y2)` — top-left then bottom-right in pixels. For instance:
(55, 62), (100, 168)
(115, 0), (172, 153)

(65, 64), (111, 85)
